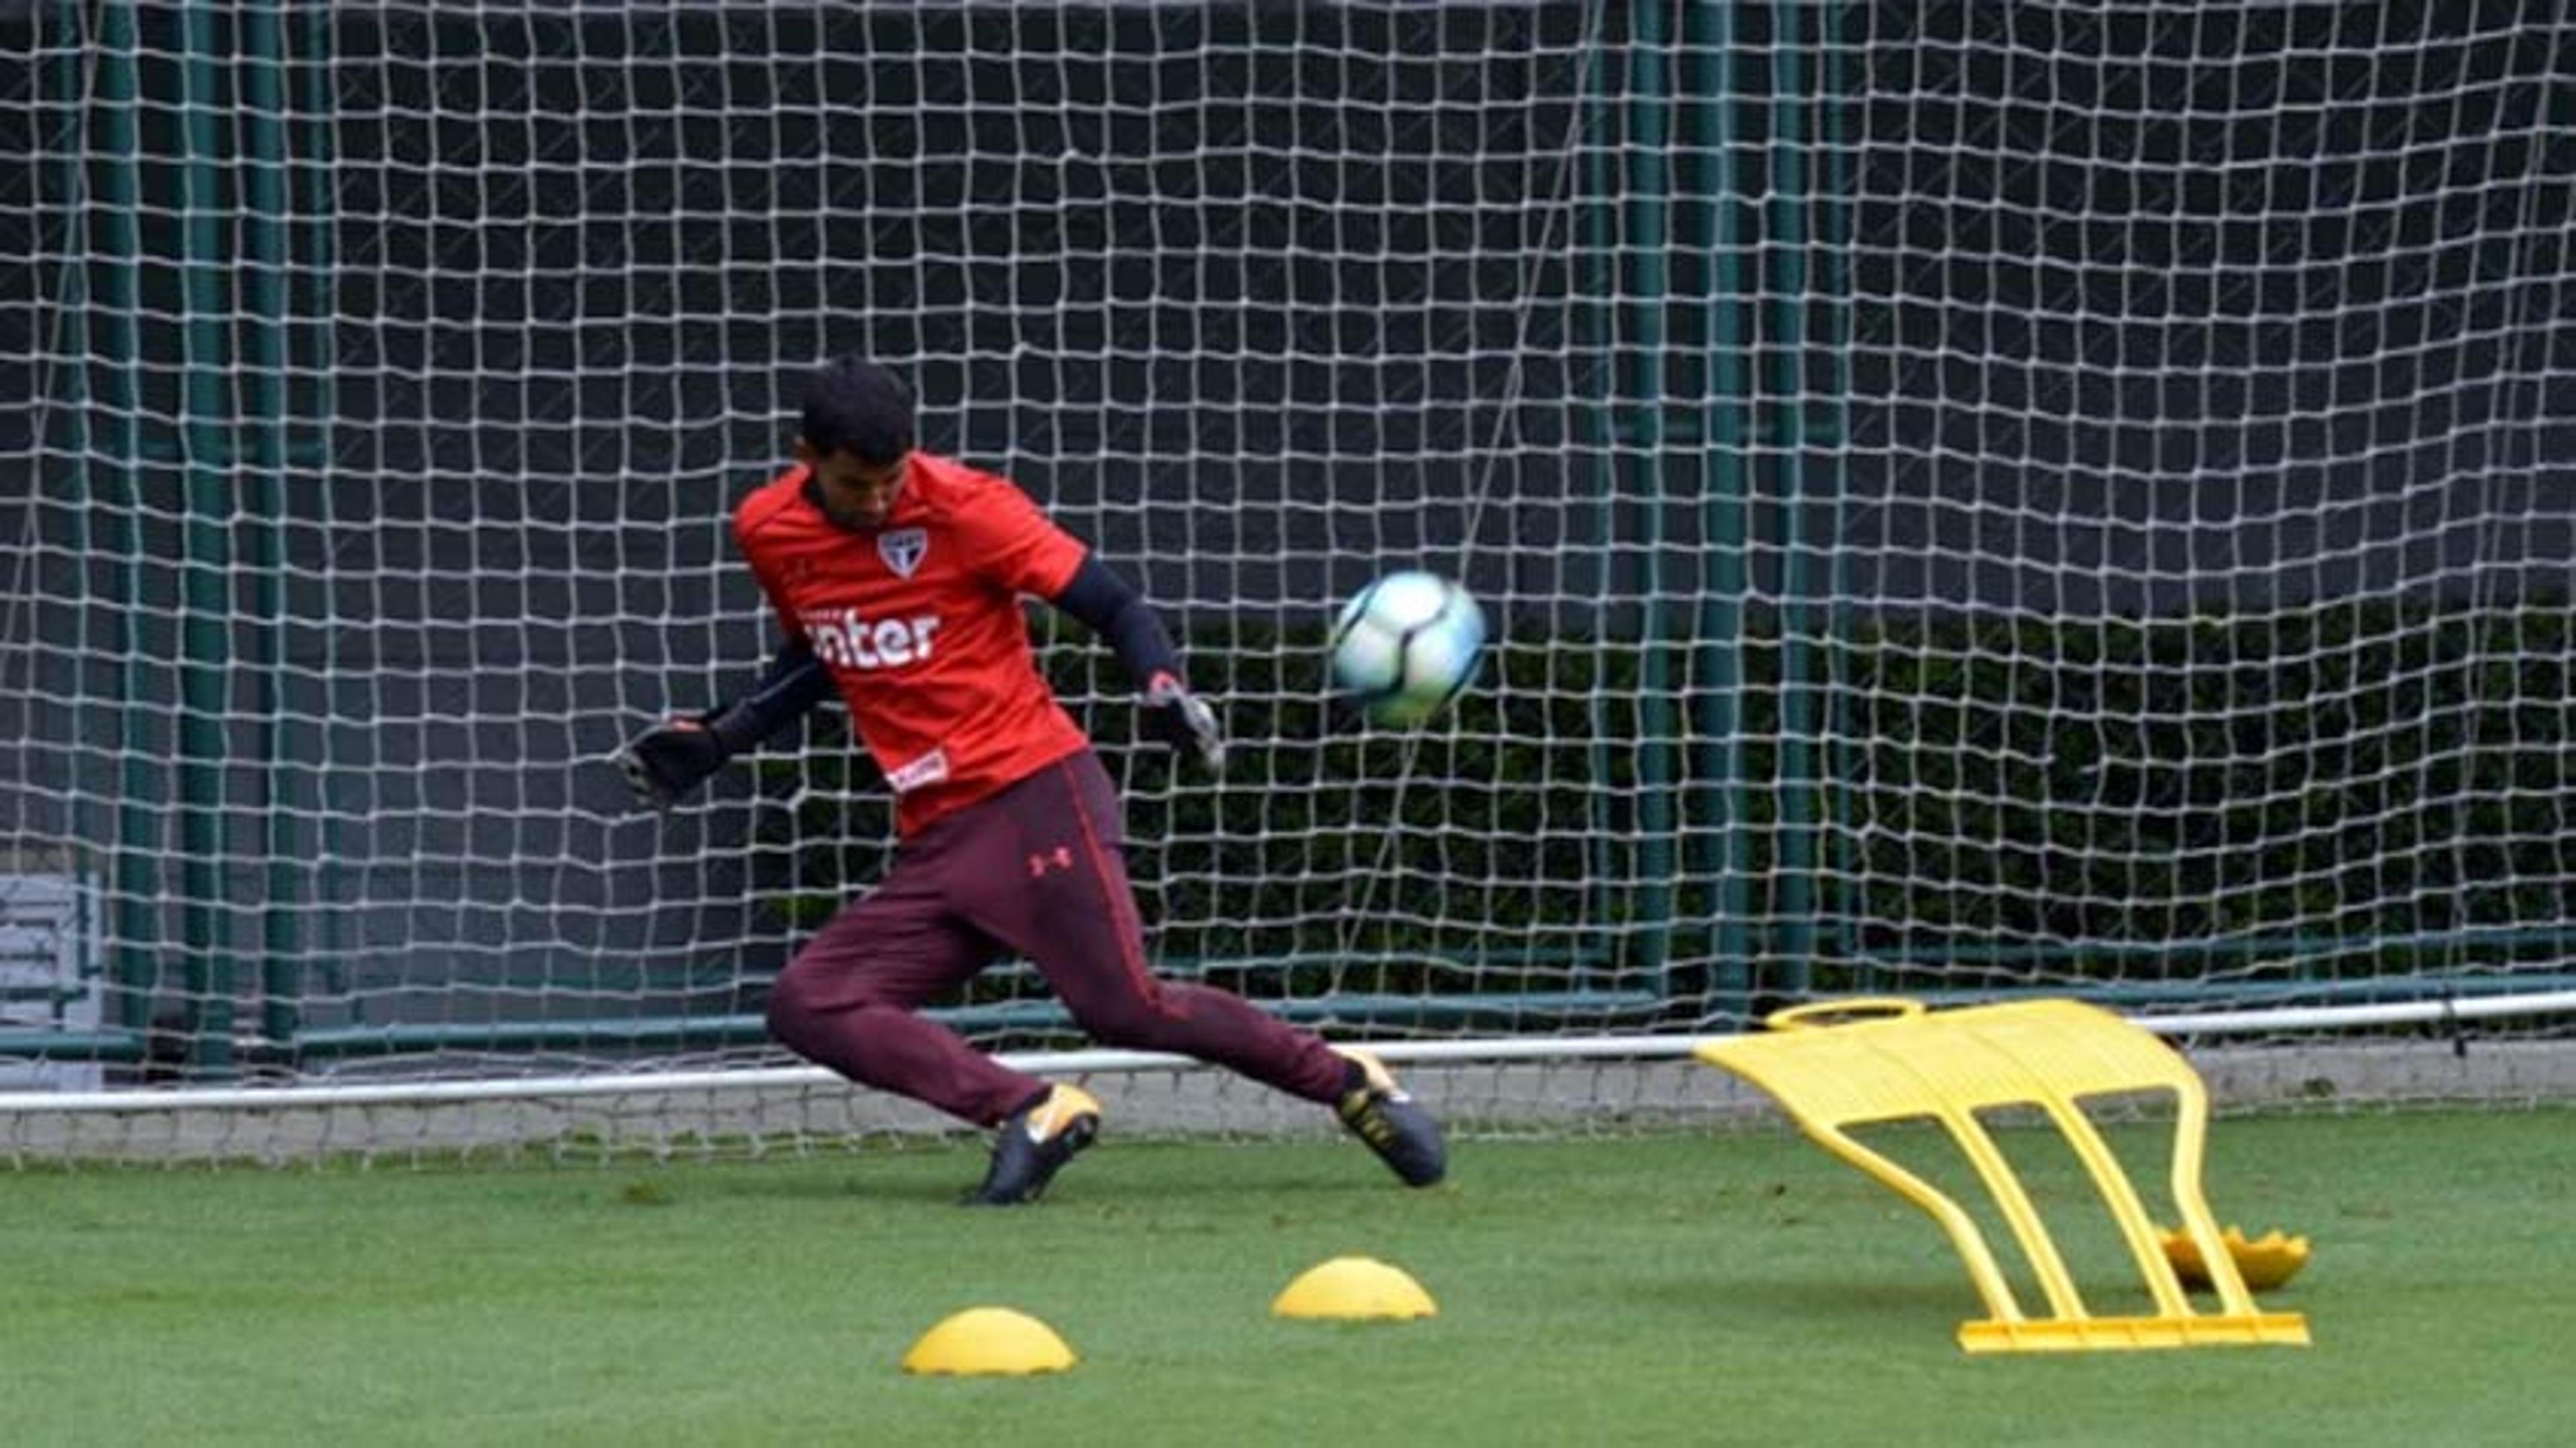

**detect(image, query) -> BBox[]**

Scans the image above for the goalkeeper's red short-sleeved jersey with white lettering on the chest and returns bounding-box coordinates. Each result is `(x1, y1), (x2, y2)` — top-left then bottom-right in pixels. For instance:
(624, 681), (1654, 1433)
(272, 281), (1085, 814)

(734, 454), (1089, 835)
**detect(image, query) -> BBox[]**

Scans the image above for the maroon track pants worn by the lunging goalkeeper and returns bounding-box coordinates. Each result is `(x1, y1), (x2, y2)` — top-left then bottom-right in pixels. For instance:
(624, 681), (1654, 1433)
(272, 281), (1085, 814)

(770, 749), (1344, 1126)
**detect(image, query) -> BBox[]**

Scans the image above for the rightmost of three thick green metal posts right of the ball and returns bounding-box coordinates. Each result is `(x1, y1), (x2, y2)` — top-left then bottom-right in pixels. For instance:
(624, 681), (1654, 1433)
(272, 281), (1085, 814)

(1767, 0), (1816, 994)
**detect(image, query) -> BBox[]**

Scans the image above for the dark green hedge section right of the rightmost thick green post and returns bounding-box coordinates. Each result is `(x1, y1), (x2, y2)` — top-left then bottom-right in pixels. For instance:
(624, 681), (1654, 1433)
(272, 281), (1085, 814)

(1837, 592), (2576, 976)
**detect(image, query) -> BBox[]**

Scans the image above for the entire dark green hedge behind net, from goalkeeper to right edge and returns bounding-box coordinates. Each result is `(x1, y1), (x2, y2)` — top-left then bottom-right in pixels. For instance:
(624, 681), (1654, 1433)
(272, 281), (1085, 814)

(763, 592), (2576, 1013)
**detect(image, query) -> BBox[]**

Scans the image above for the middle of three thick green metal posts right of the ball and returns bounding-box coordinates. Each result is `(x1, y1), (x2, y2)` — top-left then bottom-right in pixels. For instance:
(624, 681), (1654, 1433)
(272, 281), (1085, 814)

(1693, 0), (1754, 1018)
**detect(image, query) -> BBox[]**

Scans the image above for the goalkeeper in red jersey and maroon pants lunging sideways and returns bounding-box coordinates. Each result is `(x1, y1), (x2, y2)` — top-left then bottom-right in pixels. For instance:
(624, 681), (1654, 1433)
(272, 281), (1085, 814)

(619, 358), (1445, 1206)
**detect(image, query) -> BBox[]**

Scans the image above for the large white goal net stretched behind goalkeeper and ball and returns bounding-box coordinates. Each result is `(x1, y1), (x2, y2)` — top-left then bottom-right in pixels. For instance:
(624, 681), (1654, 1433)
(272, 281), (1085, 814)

(0, 0), (2576, 1154)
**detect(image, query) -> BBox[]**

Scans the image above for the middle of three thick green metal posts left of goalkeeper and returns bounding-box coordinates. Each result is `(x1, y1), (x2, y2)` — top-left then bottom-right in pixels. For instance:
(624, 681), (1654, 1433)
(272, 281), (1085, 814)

(178, 5), (234, 1077)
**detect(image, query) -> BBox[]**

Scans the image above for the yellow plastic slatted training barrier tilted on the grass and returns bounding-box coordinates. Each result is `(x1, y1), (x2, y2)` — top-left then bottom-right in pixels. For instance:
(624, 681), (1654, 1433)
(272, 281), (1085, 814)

(1693, 997), (2308, 1353)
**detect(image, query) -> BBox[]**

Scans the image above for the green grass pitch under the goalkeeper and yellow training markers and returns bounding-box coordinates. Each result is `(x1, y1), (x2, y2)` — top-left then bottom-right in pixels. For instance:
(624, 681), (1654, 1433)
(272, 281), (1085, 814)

(0, 1113), (2576, 1445)
